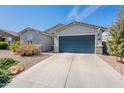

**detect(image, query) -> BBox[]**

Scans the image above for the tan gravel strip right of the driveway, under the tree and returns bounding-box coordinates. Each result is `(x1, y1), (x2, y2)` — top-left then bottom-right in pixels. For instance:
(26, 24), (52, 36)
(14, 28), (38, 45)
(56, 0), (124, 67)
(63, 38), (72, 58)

(98, 55), (124, 75)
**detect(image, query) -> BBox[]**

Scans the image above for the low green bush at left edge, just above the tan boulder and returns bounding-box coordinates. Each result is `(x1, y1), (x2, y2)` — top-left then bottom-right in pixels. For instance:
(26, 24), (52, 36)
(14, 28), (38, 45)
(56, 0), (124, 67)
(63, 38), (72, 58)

(0, 58), (19, 69)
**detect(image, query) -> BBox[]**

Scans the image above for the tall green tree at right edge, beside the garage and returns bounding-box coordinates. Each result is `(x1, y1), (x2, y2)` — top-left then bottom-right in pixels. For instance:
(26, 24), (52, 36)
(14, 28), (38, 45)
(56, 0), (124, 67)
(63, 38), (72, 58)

(107, 7), (124, 62)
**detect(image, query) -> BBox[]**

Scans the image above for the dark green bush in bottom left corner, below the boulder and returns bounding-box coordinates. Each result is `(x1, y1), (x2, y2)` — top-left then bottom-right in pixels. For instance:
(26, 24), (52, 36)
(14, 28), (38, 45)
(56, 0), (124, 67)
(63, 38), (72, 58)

(0, 69), (11, 87)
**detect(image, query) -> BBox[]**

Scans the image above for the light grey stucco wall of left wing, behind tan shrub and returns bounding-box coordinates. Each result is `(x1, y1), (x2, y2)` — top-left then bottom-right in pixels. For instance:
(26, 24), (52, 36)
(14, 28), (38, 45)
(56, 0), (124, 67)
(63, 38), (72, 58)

(20, 31), (53, 51)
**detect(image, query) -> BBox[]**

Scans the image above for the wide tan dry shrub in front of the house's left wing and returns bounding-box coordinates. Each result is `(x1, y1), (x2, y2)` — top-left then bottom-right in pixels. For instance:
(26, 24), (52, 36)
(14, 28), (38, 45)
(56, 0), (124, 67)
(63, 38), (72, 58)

(16, 44), (41, 56)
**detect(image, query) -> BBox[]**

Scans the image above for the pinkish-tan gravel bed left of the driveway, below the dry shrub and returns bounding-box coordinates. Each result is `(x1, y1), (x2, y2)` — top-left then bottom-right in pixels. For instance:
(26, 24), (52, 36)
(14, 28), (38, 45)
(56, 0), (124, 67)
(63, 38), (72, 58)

(0, 50), (51, 70)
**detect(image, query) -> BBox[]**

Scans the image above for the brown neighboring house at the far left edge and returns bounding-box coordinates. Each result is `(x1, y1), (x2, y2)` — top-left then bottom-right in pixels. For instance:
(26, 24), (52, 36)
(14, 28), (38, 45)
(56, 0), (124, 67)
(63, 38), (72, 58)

(0, 29), (19, 42)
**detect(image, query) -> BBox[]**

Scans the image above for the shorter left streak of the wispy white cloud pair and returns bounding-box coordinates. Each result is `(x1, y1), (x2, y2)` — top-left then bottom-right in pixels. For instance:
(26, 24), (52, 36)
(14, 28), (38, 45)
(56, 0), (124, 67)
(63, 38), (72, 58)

(67, 5), (79, 21)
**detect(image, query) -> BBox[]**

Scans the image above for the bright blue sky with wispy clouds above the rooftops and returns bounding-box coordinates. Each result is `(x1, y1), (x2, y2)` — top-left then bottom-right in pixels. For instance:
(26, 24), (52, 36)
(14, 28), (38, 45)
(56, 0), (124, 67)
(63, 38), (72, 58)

(0, 5), (124, 32)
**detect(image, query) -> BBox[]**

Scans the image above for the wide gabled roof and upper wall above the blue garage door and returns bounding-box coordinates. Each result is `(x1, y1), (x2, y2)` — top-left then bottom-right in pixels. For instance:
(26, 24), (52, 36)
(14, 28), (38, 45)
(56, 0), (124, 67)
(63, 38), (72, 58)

(45, 21), (107, 35)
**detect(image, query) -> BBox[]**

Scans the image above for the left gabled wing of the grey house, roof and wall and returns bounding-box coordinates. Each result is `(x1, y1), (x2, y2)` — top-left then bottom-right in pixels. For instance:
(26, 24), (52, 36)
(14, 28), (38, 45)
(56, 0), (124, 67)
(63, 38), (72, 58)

(19, 27), (53, 51)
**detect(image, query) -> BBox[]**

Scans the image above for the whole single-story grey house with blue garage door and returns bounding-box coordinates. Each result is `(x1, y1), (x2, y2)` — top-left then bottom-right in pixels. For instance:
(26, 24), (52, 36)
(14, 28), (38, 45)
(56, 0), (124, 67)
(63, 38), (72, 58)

(20, 21), (107, 54)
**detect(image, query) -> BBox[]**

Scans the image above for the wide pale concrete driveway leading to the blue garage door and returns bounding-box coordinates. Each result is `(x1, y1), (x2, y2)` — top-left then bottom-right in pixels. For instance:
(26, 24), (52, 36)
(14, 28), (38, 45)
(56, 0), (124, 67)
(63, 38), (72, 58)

(6, 53), (124, 88)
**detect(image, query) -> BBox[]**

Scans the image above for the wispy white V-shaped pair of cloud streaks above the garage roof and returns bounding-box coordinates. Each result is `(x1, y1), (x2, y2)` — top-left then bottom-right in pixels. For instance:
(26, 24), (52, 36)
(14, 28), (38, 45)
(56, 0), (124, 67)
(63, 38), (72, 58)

(67, 5), (100, 21)
